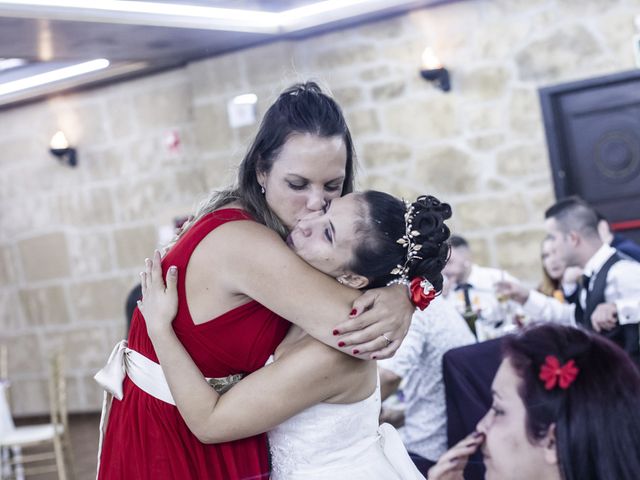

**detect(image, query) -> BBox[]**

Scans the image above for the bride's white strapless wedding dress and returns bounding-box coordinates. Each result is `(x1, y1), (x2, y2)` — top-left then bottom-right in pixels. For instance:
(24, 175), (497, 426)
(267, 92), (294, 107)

(269, 372), (424, 480)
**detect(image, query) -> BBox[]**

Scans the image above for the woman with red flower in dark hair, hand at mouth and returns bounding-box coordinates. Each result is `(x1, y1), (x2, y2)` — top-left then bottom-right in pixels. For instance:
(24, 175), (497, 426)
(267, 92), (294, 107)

(428, 324), (640, 480)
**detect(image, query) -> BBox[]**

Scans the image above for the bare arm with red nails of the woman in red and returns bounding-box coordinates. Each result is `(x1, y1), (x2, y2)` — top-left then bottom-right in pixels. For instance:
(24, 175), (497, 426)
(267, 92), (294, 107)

(207, 222), (414, 358)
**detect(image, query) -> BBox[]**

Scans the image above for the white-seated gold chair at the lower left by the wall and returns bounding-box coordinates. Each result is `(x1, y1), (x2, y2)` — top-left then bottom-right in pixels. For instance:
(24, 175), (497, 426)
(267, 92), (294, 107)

(0, 354), (73, 480)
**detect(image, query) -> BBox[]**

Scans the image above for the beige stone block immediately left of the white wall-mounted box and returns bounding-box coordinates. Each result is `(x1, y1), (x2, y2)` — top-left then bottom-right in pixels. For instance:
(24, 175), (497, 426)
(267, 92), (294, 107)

(193, 102), (238, 154)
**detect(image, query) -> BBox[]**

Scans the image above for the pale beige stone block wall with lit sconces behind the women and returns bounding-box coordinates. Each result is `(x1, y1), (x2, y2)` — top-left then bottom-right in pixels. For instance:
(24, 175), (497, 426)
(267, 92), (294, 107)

(0, 0), (640, 415)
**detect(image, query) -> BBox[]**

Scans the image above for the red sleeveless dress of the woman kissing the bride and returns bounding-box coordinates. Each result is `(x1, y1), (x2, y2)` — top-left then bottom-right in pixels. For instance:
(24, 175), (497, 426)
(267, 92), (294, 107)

(98, 209), (289, 480)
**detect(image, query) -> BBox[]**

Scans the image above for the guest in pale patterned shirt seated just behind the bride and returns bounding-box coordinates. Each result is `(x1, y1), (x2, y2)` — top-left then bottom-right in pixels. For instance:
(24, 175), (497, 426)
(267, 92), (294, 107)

(378, 298), (475, 476)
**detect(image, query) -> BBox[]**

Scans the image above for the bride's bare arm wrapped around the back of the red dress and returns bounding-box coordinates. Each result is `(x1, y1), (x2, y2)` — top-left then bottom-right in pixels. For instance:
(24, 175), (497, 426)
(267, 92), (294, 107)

(139, 265), (364, 443)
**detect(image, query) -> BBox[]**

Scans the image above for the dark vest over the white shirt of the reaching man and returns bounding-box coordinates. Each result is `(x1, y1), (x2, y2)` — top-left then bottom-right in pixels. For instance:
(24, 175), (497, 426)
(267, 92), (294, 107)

(572, 253), (640, 364)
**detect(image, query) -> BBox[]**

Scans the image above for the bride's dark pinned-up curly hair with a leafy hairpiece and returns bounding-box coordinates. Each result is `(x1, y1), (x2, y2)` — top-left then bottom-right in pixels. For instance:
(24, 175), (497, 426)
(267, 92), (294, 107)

(349, 190), (451, 291)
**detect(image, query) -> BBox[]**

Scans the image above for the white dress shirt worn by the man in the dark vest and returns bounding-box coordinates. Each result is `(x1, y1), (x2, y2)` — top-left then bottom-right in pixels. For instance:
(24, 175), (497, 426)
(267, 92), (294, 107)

(523, 244), (640, 325)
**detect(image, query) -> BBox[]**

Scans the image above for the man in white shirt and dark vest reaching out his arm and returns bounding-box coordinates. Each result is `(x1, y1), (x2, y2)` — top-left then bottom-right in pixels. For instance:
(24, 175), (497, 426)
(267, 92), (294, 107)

(503, 197), (640, 364)
